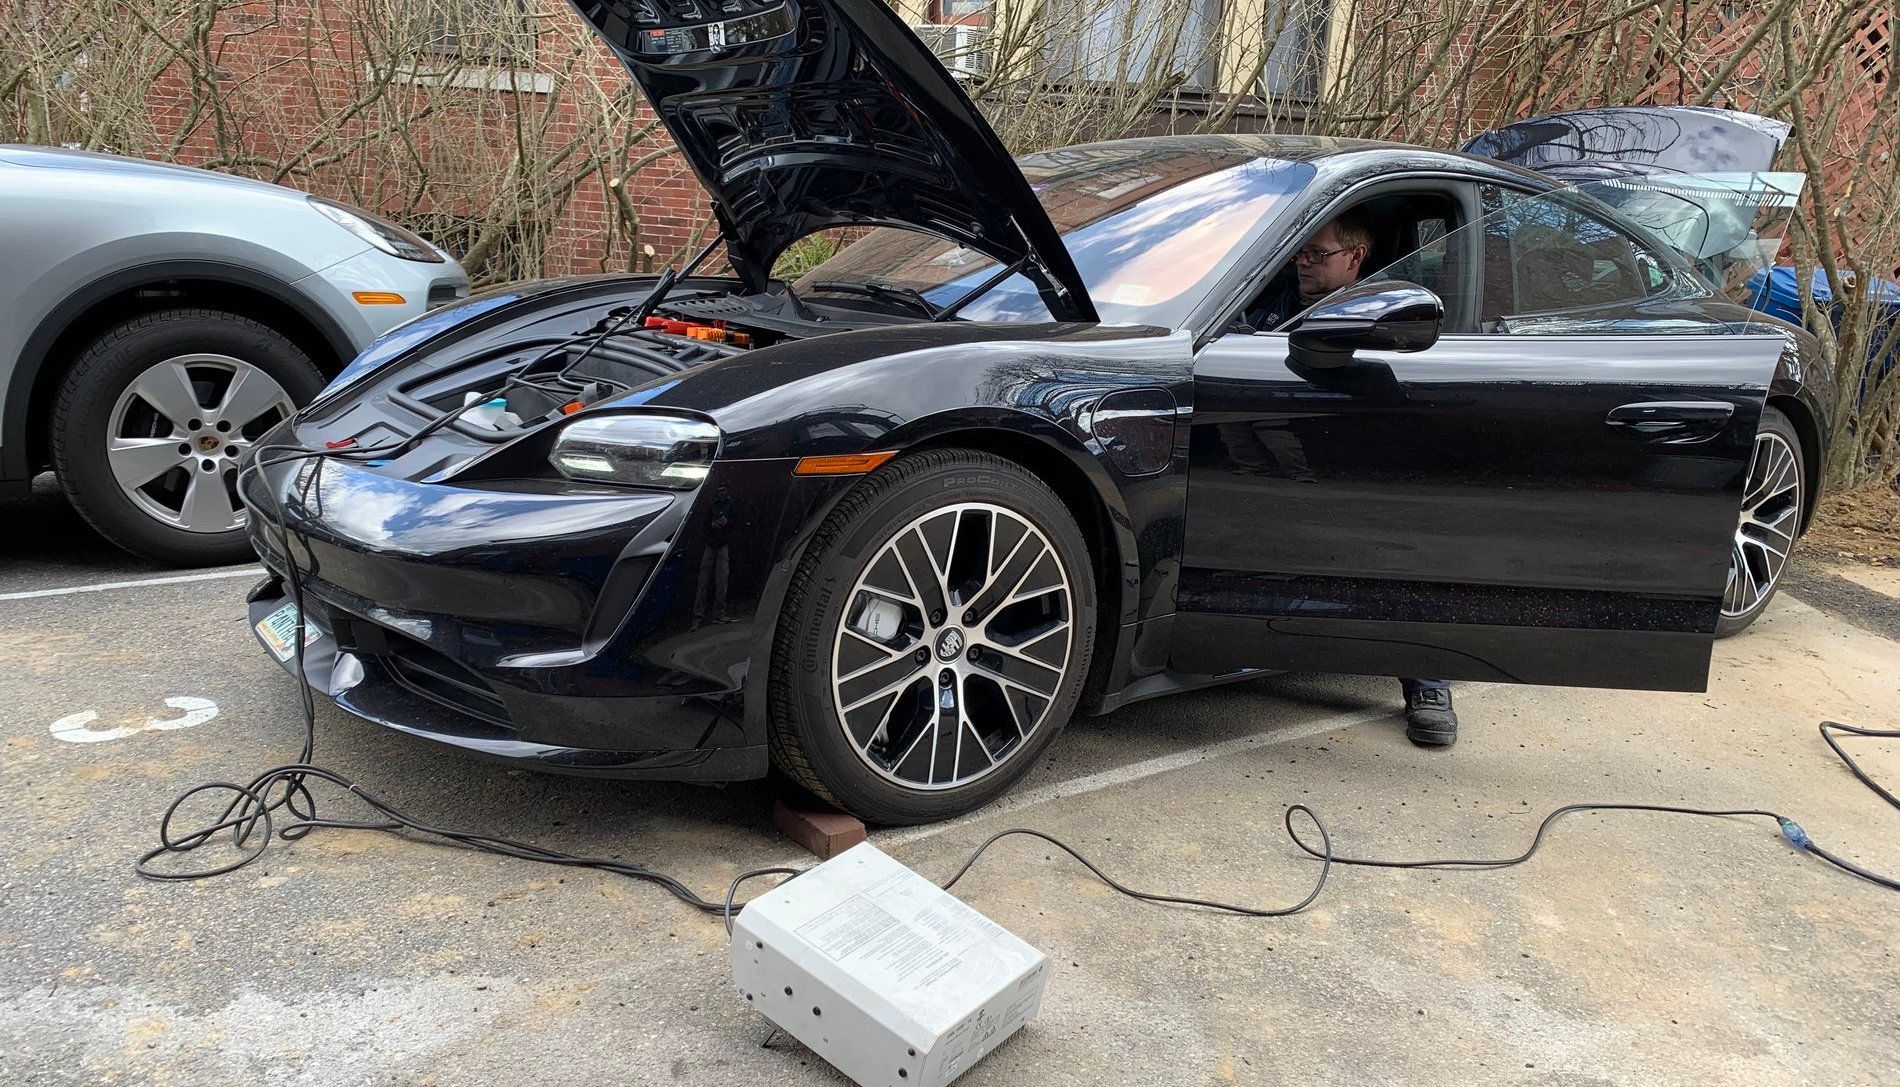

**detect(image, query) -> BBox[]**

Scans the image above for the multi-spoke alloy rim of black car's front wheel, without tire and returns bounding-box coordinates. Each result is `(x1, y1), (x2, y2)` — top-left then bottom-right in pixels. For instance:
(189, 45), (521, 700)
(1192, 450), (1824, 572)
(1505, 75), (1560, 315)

(832, 502), (1075, 791)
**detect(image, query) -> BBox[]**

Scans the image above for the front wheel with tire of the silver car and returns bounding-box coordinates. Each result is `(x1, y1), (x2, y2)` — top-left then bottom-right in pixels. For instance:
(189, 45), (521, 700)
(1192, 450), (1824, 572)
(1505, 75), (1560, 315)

(51, 310), (323, 566)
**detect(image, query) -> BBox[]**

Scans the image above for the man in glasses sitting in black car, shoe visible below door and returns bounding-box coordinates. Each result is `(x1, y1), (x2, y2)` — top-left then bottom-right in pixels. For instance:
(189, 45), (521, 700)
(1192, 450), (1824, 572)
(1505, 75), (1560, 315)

(1246, 209), (1457, 747)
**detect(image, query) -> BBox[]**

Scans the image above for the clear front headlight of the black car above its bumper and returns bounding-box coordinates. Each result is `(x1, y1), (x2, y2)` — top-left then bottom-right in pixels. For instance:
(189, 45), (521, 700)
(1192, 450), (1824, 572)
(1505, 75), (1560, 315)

(547, 414), (720, 490)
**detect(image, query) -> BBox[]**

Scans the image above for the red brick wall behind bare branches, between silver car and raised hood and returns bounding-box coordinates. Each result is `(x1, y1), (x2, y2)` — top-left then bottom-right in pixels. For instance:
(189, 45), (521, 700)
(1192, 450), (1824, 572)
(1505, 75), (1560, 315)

(127, 0), (709, 277)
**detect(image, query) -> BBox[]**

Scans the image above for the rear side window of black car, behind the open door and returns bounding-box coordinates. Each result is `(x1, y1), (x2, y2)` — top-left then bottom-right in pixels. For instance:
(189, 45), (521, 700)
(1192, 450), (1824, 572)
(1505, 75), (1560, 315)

(1480, 184), (1670, 333)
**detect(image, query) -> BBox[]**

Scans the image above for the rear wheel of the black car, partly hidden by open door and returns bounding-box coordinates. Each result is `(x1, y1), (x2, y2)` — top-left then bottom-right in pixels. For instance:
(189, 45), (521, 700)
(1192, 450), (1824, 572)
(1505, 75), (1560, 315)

(1716, 409), (1809, 639)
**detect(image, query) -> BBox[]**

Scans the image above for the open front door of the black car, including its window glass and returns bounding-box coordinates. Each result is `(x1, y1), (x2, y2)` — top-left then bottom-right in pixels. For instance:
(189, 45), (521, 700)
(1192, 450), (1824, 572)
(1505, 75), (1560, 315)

(1170, 182), (1794, 690)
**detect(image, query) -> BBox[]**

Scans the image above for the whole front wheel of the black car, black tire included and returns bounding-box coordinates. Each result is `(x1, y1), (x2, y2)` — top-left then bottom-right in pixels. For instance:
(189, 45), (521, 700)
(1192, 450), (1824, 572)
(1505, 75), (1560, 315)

(770, 448), (1094, 825)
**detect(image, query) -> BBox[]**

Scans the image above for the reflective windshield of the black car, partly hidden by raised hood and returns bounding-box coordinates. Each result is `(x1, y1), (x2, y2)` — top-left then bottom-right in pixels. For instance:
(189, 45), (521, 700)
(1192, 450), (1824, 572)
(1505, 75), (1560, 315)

(794, 143), (1313, 327)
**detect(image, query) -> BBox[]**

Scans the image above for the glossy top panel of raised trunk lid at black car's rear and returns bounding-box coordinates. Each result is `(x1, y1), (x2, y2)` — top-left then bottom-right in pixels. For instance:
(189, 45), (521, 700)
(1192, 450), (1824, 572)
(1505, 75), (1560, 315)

(1463, 106), (1788, 184)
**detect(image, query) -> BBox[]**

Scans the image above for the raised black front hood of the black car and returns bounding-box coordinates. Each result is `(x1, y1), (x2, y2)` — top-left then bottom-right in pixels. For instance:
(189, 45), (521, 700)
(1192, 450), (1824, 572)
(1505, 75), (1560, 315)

(570, 0), (1096, 321)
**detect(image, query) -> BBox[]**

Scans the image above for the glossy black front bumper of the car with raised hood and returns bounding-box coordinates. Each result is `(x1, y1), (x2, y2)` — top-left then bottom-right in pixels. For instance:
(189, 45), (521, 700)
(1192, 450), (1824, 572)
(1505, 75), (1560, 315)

(243, 450), (770, 781)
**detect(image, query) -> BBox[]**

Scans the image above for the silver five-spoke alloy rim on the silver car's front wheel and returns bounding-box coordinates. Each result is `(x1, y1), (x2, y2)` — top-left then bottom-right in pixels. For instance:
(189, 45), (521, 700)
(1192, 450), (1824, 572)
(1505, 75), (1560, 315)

(106, 353), (296, 532)
